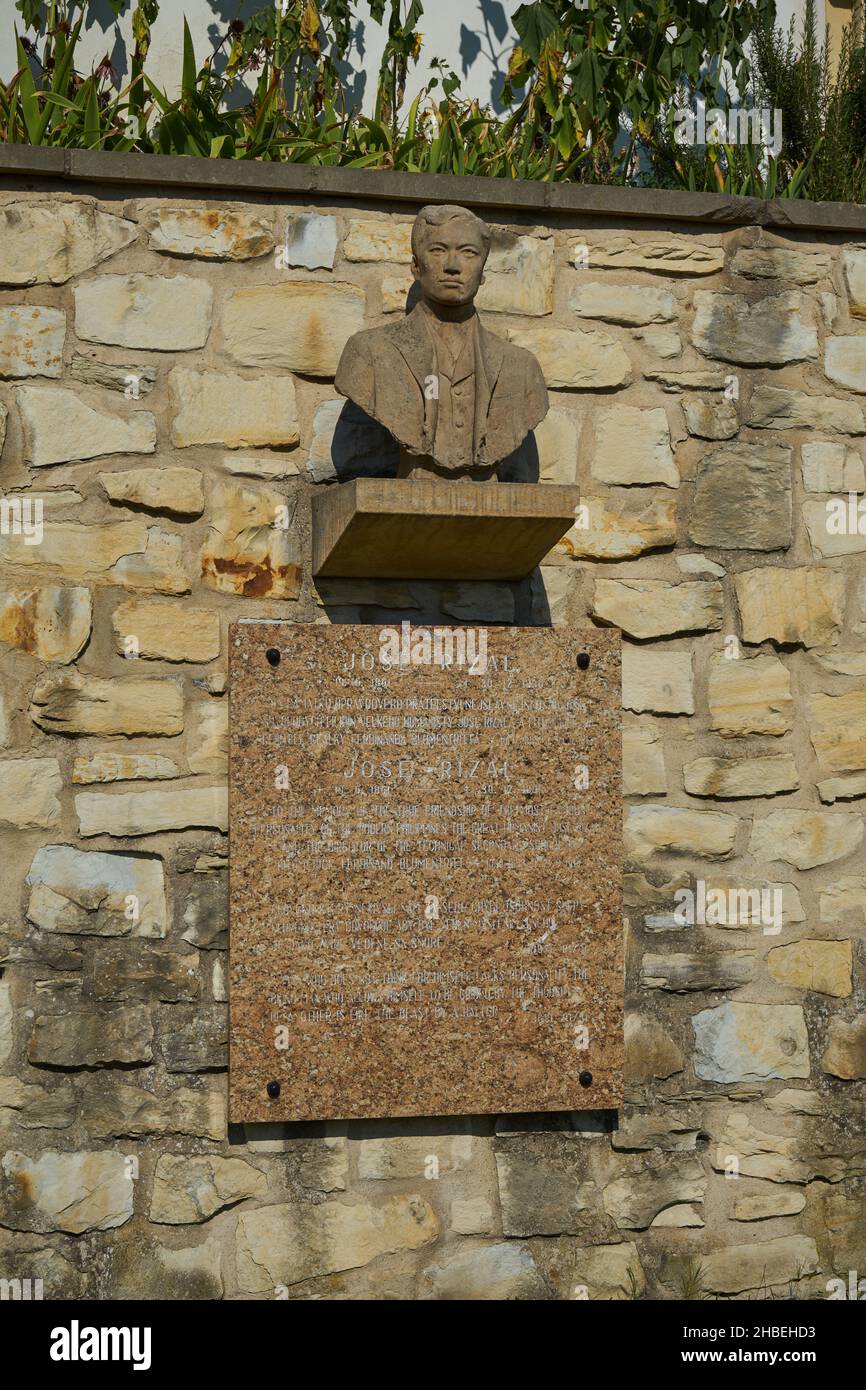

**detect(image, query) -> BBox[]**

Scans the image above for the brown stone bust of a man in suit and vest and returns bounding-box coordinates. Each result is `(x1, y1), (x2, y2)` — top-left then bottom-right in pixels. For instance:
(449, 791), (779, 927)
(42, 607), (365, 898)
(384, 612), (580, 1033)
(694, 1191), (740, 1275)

(335, 204), (548, 481)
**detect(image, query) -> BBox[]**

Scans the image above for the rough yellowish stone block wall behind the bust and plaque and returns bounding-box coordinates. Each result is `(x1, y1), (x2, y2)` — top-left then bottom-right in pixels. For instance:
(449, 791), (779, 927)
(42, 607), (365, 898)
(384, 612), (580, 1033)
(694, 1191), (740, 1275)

(0, 156), (866, 1300)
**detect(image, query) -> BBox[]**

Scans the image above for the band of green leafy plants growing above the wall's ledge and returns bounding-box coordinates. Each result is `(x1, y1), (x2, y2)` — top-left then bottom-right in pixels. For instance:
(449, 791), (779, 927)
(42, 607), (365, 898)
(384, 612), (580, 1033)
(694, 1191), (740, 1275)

(0, 0), (866, 202)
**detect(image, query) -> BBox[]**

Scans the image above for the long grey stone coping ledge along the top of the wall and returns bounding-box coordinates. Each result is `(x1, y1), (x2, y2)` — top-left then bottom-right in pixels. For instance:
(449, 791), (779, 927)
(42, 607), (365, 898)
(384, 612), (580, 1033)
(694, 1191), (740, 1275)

(0, 145), (866, 234)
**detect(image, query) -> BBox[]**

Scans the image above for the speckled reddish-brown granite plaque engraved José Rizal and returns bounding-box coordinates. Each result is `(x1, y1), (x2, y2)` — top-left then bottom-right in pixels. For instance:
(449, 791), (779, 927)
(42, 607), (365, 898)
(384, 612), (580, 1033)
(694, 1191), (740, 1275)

(229, 623), (623, 1122)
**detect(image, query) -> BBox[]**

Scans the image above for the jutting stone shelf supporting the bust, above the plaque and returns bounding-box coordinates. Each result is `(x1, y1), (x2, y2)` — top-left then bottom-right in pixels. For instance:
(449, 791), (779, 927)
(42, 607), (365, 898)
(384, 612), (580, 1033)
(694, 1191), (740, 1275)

(313, 478), (580, 580)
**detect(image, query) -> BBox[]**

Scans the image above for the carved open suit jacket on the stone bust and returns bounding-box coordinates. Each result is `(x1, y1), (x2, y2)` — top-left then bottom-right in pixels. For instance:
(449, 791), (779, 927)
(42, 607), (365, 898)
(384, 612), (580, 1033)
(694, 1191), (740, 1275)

(334, 303), (548, 468)
